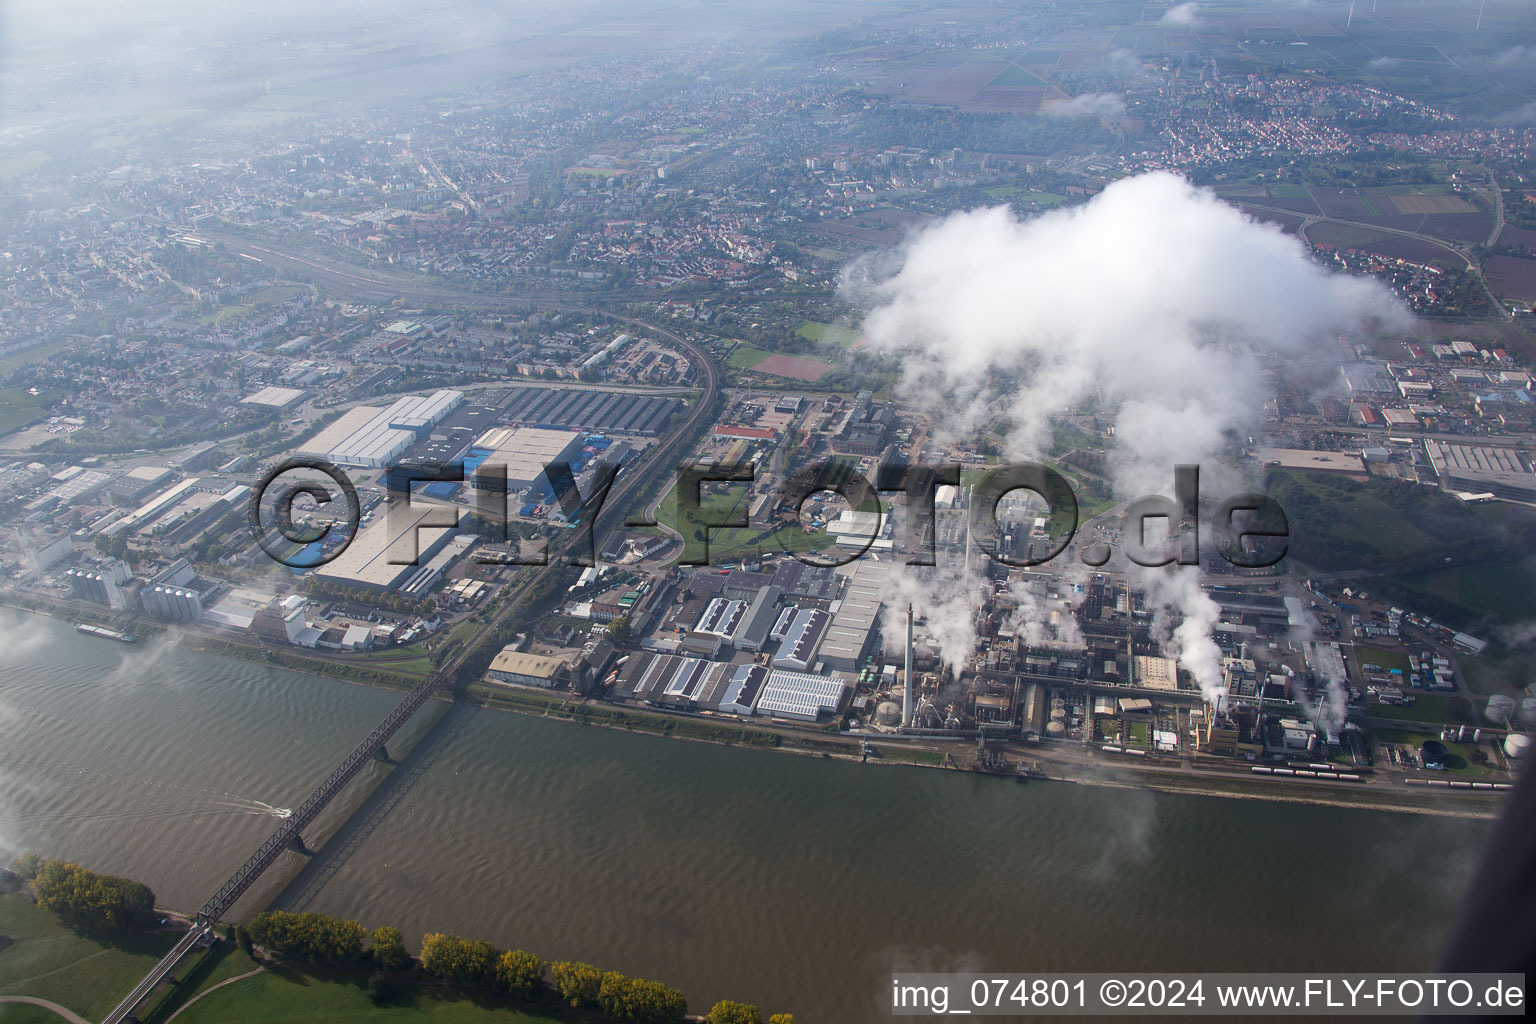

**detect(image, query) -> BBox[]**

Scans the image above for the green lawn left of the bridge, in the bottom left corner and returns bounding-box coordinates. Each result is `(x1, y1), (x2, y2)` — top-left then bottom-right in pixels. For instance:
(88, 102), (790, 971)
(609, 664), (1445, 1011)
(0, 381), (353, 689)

(0, 894), (177, 1021)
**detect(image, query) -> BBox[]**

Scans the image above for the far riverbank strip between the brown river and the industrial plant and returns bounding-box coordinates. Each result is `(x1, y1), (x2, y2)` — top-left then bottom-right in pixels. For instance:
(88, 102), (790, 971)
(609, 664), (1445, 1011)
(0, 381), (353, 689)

(3, 594), (1502, 820)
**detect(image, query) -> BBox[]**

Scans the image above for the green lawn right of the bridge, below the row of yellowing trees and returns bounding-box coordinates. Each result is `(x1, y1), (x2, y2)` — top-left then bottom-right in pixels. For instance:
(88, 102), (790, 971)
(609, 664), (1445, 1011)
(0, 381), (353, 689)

(177, 969), (571, 1024)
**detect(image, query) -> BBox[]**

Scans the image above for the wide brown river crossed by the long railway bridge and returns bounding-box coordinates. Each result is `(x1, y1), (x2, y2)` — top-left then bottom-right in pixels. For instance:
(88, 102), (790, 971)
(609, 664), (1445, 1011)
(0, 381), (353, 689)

(0, 609), (1490, 1024)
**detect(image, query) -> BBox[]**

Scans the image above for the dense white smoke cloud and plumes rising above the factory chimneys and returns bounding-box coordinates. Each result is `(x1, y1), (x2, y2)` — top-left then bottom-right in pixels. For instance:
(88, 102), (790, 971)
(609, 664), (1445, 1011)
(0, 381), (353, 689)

(843, 172), (1407, 697)
